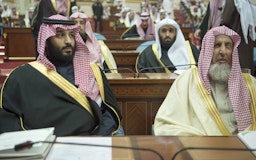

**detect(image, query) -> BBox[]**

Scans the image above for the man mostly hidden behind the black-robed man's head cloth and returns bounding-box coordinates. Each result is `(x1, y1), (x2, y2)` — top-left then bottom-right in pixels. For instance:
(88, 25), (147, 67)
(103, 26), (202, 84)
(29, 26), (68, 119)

(70, 12), (117, 72)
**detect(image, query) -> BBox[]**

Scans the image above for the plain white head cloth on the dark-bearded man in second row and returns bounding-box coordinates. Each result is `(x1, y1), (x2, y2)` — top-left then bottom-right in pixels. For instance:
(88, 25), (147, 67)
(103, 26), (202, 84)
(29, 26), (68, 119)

(155, 18), (190, 70)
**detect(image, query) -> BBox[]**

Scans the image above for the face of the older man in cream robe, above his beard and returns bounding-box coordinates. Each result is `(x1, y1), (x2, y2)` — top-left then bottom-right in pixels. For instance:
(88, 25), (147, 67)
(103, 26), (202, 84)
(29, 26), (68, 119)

(212, 35), (234, 65)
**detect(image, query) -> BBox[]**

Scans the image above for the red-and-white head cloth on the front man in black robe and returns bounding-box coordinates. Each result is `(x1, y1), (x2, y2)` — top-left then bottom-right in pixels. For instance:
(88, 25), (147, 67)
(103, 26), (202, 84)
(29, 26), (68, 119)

(37, 15), (99, 100)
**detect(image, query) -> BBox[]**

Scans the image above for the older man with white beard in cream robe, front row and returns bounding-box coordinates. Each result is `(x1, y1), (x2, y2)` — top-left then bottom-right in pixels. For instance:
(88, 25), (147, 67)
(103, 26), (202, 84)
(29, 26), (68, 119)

(154, 26), (256, 136)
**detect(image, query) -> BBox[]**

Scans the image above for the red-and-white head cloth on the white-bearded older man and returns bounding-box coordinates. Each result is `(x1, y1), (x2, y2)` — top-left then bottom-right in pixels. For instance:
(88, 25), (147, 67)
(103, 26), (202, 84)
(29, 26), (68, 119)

(198, 26), (251, 131)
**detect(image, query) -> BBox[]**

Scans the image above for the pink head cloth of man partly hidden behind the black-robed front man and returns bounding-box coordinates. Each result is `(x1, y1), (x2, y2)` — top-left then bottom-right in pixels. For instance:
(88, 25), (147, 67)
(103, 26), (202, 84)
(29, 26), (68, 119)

(70, 12), (102, 64)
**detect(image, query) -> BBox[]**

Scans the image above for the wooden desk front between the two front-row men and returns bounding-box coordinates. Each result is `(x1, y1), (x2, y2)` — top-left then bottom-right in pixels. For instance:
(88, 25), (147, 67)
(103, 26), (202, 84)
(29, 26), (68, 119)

(106, 73), (177, 135)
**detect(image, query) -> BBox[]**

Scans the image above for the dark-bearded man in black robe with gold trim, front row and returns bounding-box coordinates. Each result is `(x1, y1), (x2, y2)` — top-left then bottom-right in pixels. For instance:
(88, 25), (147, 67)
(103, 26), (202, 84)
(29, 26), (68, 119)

(0, 15), (121, 136)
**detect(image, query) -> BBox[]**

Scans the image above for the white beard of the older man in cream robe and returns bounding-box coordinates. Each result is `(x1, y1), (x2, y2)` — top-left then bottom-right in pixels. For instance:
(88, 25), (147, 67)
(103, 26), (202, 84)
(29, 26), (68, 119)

(208, 63), (231, 83)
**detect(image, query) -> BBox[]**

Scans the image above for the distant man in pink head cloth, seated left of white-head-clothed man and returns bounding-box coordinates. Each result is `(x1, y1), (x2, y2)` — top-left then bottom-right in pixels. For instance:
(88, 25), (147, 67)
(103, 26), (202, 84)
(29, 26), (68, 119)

(121, 12), (155, 40)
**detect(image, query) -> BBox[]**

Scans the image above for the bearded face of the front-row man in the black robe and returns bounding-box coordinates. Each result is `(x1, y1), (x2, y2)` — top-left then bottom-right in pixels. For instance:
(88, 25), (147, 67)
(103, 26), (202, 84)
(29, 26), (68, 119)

(46, 28), (75, 62)
